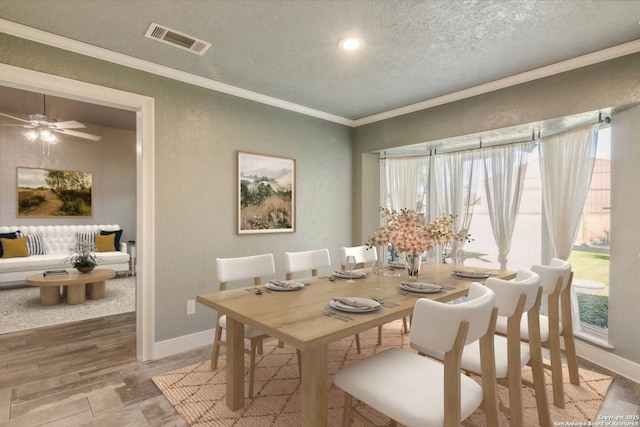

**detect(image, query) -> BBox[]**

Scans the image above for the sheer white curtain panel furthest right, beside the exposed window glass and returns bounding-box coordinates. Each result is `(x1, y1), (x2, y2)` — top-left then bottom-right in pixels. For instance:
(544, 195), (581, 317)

(538, 124), (598, 260)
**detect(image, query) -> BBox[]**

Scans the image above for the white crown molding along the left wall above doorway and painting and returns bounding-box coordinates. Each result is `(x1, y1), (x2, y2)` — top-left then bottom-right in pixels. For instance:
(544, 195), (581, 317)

(0, 18), (353, 126)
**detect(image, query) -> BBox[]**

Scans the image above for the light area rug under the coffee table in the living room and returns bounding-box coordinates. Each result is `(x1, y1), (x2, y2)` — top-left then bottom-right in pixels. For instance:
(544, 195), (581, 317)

(0, 277), (136, 334)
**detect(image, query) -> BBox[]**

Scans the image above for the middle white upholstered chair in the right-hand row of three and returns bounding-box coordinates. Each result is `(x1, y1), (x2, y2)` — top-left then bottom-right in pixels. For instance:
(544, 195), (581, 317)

(425, 270), (551, 427)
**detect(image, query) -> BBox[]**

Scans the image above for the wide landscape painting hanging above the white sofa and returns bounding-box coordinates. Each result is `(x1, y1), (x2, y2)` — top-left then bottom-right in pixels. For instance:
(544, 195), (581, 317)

(16, 167), (93, 218)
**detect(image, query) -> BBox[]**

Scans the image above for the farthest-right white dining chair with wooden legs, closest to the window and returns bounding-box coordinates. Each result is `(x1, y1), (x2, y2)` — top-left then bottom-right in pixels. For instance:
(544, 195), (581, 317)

(496, 258), (580, 408)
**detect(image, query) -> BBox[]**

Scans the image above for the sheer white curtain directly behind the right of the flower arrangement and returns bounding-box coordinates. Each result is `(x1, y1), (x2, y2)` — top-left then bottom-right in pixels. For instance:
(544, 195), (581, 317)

(434, 150), (479, 254)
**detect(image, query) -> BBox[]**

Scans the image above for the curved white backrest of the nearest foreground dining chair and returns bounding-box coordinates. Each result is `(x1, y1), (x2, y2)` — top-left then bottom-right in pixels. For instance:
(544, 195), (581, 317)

(410, 282), (495, 354)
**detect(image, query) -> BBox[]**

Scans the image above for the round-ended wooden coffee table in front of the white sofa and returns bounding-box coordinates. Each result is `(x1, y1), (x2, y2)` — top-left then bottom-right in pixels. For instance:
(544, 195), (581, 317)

(25, 268), (116, 305)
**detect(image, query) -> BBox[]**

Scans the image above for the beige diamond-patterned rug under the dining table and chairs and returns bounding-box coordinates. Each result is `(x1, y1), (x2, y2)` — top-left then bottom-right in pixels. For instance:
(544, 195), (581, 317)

(152, 321), (612, 427)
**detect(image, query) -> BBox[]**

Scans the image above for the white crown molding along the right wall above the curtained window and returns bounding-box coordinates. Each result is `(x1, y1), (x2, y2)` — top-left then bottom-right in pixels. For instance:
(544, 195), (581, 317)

(353, 39), (640, 127)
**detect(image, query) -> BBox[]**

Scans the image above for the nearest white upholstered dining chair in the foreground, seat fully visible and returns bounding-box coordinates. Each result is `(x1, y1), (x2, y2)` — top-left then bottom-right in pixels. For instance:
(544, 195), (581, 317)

(333, 283), (498, 427)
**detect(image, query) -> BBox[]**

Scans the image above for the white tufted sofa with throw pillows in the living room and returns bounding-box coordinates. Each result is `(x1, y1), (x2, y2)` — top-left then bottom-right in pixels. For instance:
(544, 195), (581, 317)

(0, 224), (129, 287)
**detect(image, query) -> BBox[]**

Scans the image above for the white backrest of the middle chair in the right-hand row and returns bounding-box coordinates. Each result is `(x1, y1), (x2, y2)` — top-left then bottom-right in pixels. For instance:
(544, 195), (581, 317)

(485, 270), (540, 317)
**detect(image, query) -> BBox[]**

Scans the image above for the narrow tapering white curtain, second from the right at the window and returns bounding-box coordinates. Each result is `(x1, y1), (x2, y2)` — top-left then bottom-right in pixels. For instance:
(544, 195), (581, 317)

(482, 144), (528, 269)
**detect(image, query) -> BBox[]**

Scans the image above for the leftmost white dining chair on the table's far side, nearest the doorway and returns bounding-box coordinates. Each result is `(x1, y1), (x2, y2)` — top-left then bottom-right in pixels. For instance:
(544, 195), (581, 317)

(211, 254), (276, 399)
